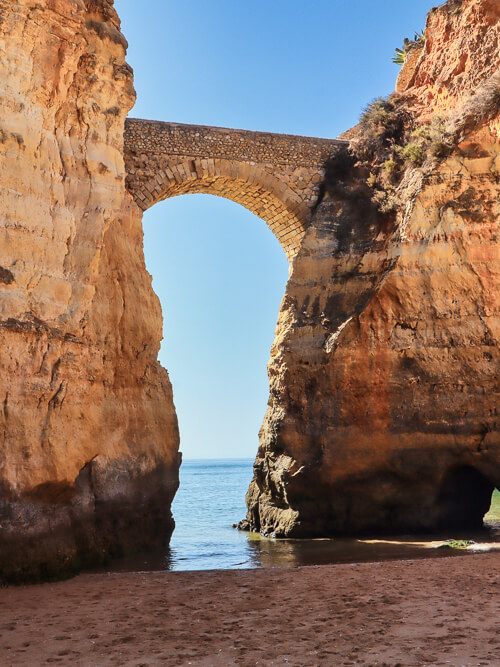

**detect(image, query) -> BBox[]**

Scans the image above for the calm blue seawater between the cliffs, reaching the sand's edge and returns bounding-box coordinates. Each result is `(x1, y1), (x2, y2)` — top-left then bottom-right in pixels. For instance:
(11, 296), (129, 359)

(100, 459), (500, 571)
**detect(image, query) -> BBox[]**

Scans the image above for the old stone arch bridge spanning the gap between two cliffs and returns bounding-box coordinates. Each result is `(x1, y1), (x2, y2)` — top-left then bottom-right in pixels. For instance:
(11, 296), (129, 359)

(125, 118), (348, 260)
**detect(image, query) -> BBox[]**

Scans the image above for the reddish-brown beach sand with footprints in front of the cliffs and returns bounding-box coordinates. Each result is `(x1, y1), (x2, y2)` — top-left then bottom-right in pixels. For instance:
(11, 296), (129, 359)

(0, 553), (500, 667)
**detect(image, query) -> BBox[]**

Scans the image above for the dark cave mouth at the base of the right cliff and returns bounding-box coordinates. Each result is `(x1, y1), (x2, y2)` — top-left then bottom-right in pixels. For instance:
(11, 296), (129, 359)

(438, 466), (495, 530)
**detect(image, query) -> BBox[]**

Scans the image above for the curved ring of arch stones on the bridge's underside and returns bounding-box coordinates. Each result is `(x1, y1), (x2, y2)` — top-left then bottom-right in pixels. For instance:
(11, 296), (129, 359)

(138, 158), (310, 260)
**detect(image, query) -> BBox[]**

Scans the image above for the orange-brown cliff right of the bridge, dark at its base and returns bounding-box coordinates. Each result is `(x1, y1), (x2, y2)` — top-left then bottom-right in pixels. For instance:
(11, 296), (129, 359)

(243, 0), (500, 536)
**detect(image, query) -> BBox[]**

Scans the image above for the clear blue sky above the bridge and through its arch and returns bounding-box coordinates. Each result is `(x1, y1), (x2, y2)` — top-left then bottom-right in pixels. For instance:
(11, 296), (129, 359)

(115, 0), (440, 458)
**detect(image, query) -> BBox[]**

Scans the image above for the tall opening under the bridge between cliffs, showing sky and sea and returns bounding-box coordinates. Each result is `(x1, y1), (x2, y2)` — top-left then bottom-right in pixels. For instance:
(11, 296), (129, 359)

(144, 194), (288, 569)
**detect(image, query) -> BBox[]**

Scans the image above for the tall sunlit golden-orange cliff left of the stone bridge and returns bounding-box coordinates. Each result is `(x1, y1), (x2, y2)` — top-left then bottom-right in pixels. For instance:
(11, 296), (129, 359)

(0, 0), (178, 580)
